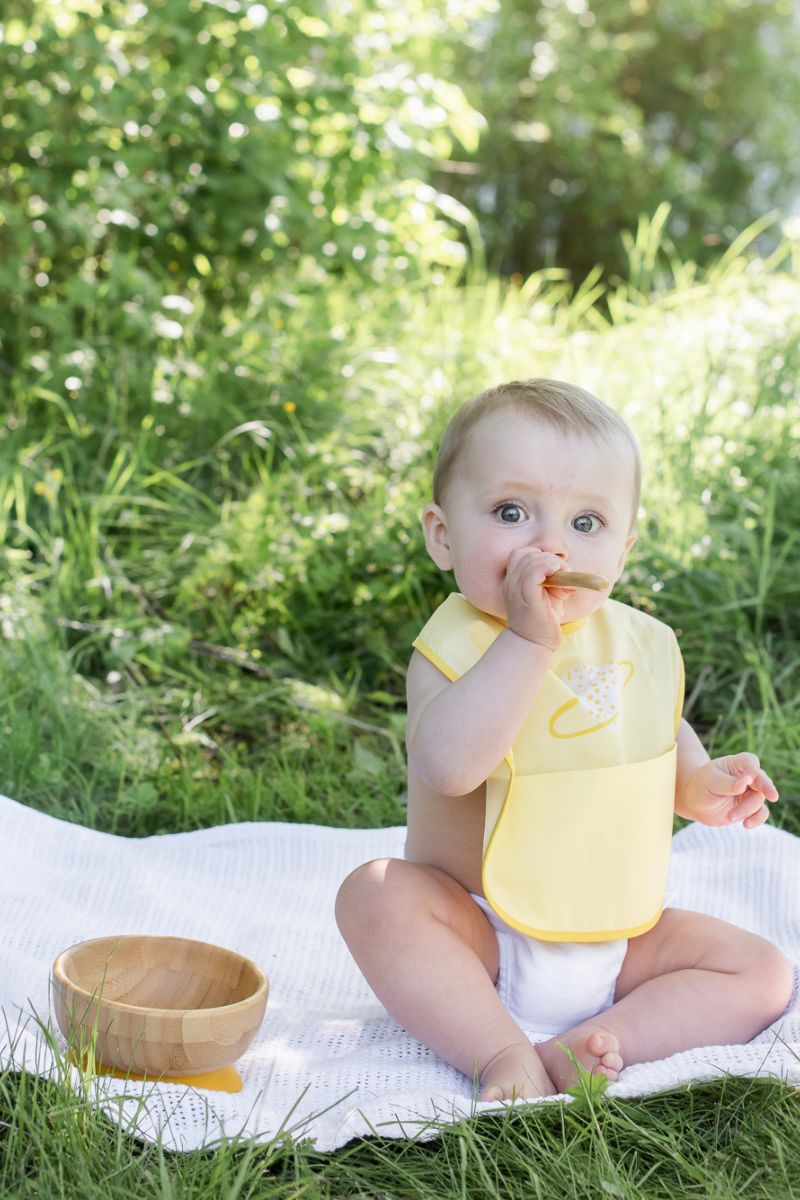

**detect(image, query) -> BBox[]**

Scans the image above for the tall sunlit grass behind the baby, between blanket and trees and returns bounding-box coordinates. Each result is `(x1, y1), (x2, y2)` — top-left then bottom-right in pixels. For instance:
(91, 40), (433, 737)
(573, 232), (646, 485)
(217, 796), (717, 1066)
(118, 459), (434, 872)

(0, 236), (800, 834)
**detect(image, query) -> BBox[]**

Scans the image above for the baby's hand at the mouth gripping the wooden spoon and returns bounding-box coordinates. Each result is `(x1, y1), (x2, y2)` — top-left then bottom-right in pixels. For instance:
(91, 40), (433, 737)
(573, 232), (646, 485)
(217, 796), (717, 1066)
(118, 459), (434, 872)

(503, 546), (566, 650)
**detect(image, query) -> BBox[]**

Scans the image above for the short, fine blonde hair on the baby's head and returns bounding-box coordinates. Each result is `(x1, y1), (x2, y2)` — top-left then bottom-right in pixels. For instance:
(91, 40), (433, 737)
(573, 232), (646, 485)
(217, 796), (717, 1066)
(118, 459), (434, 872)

(433, 379), (642, 524)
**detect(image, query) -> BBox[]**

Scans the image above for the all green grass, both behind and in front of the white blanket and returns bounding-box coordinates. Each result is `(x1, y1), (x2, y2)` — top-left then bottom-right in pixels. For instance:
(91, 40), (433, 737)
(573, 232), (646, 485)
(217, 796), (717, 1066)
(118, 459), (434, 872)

(0, 231), (800, 1200)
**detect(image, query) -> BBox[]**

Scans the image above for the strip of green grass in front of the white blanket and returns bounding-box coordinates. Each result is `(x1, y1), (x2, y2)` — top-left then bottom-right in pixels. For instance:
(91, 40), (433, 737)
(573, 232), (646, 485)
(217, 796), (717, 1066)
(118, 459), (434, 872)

(0, 1075), (800, 1200)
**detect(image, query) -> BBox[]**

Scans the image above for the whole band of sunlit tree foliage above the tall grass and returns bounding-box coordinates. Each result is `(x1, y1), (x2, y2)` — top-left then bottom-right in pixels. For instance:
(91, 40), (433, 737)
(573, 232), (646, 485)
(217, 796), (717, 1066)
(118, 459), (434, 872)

(0, 0), (800, 373)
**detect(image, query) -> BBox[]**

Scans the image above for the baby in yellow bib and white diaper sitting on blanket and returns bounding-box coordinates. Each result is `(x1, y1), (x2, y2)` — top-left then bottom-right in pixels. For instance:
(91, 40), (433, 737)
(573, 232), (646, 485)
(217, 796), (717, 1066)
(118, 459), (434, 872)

(337, 379), (792, 1100)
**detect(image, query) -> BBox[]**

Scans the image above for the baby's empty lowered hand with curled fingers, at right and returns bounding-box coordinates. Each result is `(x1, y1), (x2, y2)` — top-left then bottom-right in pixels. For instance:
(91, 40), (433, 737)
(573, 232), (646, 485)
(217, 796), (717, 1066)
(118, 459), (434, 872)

(684, 754), (778, 829)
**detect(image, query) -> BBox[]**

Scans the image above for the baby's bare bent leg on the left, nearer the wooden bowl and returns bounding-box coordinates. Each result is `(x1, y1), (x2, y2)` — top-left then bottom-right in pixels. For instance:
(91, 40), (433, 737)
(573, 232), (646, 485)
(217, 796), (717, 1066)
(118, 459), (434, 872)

(336, 859), (555, 1099)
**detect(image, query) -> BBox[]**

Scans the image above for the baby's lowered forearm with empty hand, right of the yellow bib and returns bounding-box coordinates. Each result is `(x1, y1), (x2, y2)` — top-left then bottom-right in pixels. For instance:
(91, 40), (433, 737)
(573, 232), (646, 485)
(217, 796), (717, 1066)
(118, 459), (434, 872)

(675, 720), (778, 829)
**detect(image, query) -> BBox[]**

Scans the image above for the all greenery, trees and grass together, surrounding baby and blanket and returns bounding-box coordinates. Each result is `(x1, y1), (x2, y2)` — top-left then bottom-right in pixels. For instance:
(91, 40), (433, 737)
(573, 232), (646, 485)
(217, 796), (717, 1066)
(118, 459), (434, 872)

(0, 0), (800, 1196)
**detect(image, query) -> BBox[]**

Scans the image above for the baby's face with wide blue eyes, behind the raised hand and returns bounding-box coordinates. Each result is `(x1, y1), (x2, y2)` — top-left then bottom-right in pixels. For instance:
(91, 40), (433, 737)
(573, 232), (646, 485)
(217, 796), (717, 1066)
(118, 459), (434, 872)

(423, 410), (636, 623)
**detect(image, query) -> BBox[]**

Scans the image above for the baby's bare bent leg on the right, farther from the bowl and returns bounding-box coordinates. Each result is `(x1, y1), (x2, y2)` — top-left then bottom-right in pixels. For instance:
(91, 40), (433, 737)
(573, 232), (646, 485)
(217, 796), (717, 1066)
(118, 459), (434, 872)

(537, 908), (792, 1085)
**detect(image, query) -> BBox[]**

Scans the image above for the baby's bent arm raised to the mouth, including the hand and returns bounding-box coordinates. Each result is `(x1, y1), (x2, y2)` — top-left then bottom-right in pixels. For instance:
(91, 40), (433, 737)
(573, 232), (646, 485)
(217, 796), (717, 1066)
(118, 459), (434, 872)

(407, 548), (563, 796)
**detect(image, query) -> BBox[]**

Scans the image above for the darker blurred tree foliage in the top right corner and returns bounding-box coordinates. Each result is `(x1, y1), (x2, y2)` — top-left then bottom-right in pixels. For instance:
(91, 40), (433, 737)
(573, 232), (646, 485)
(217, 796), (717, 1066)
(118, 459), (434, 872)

(439, 0), (800, 277)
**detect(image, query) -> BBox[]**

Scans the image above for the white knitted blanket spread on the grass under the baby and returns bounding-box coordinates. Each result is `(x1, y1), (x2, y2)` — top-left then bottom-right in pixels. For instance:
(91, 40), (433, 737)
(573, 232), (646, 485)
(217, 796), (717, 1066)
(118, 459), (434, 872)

(0, 798), (800, 1151)
